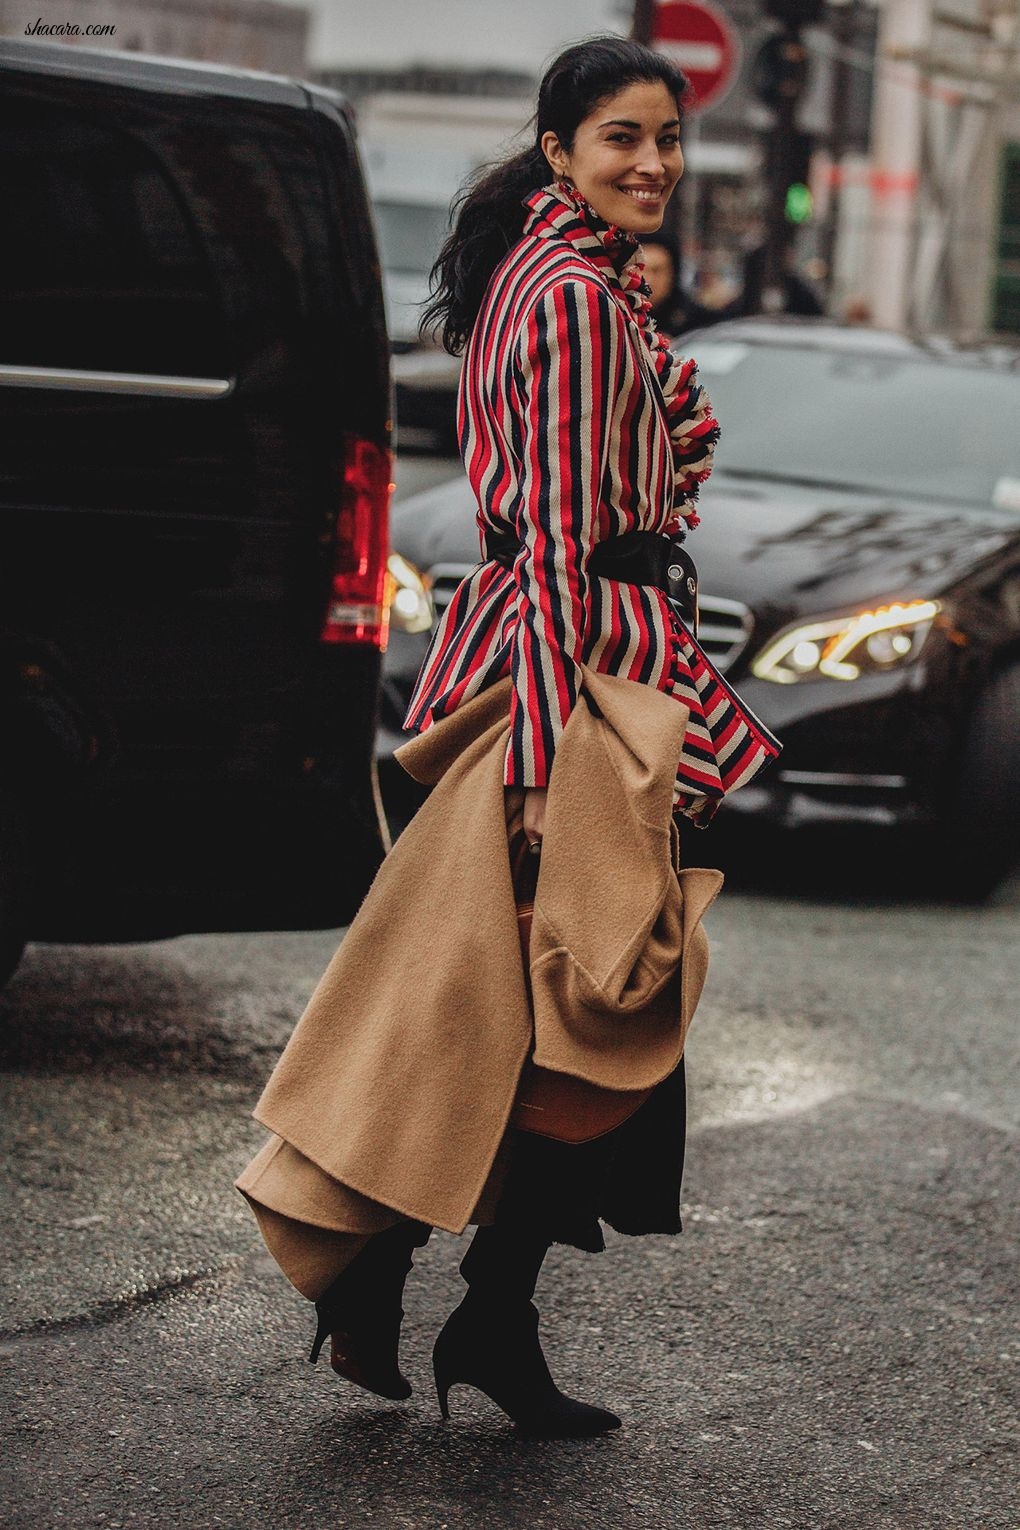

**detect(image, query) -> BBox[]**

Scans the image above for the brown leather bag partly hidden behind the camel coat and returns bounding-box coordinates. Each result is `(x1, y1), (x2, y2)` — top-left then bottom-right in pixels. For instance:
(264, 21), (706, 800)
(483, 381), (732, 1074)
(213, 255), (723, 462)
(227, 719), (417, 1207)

(509, 829), (651, 1143)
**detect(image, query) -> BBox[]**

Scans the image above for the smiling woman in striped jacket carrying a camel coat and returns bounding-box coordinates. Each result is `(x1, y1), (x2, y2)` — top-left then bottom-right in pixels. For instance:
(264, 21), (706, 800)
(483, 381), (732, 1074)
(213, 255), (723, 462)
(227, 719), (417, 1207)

(239, 37), (778, 1437)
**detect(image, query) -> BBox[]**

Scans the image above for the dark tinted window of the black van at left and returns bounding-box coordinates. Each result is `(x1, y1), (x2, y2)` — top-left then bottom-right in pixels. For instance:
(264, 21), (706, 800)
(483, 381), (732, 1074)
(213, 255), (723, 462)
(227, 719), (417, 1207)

(0, 96), (228, 376)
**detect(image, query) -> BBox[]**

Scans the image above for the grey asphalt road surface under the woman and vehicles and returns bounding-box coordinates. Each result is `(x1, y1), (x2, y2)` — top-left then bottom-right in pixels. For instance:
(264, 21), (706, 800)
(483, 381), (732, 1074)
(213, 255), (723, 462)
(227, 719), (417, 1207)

(0, 452), (1020, 1530)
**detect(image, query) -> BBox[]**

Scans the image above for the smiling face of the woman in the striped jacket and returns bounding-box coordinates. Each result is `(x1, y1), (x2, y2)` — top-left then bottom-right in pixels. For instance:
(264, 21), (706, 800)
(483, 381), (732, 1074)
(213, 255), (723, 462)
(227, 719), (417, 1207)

(541, 80), (684, 237)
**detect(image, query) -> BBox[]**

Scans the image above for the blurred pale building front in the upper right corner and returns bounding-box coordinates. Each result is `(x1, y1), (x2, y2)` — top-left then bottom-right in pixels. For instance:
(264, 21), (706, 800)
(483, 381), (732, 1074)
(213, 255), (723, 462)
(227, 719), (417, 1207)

(867, 0), (1020, 335)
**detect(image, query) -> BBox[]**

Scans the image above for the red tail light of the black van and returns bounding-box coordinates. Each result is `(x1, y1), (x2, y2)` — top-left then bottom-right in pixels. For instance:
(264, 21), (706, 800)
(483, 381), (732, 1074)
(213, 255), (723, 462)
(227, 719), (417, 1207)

(320, 436), (393, 649)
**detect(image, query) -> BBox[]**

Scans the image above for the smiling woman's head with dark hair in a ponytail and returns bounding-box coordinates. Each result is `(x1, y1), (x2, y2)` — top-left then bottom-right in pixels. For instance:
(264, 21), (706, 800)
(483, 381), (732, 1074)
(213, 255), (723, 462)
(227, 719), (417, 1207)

(422, 37), (687, 353)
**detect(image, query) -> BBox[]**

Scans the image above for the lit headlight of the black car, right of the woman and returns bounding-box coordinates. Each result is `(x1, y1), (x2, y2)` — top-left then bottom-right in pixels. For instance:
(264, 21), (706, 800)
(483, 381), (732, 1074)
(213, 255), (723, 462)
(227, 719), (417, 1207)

(751, 600), (939, 685)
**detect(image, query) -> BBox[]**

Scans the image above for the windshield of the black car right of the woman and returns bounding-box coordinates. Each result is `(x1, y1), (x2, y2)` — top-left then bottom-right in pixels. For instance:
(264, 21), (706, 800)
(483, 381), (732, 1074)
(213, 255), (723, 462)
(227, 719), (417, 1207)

(691, 337), (1020, 513)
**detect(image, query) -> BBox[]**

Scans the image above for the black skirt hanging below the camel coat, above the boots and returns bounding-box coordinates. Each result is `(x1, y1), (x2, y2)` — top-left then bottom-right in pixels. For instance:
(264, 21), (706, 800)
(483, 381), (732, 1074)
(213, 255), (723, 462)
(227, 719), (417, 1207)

(495, 1059), (687, 1253)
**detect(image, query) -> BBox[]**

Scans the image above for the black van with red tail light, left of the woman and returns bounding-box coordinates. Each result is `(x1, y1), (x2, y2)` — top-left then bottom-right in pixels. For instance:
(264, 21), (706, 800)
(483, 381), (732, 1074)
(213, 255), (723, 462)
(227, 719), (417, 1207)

(0, 41), (391, 972)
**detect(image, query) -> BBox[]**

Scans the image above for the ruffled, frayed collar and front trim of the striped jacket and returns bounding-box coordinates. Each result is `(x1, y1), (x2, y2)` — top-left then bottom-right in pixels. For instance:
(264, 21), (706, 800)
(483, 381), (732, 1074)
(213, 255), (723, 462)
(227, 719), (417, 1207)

(525, 181), (719, 528)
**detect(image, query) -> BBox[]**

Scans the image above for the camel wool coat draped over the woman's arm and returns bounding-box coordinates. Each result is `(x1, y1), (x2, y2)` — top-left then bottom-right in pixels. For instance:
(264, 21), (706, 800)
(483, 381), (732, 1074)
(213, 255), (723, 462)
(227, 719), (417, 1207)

(237, 666), (722, 1266)
